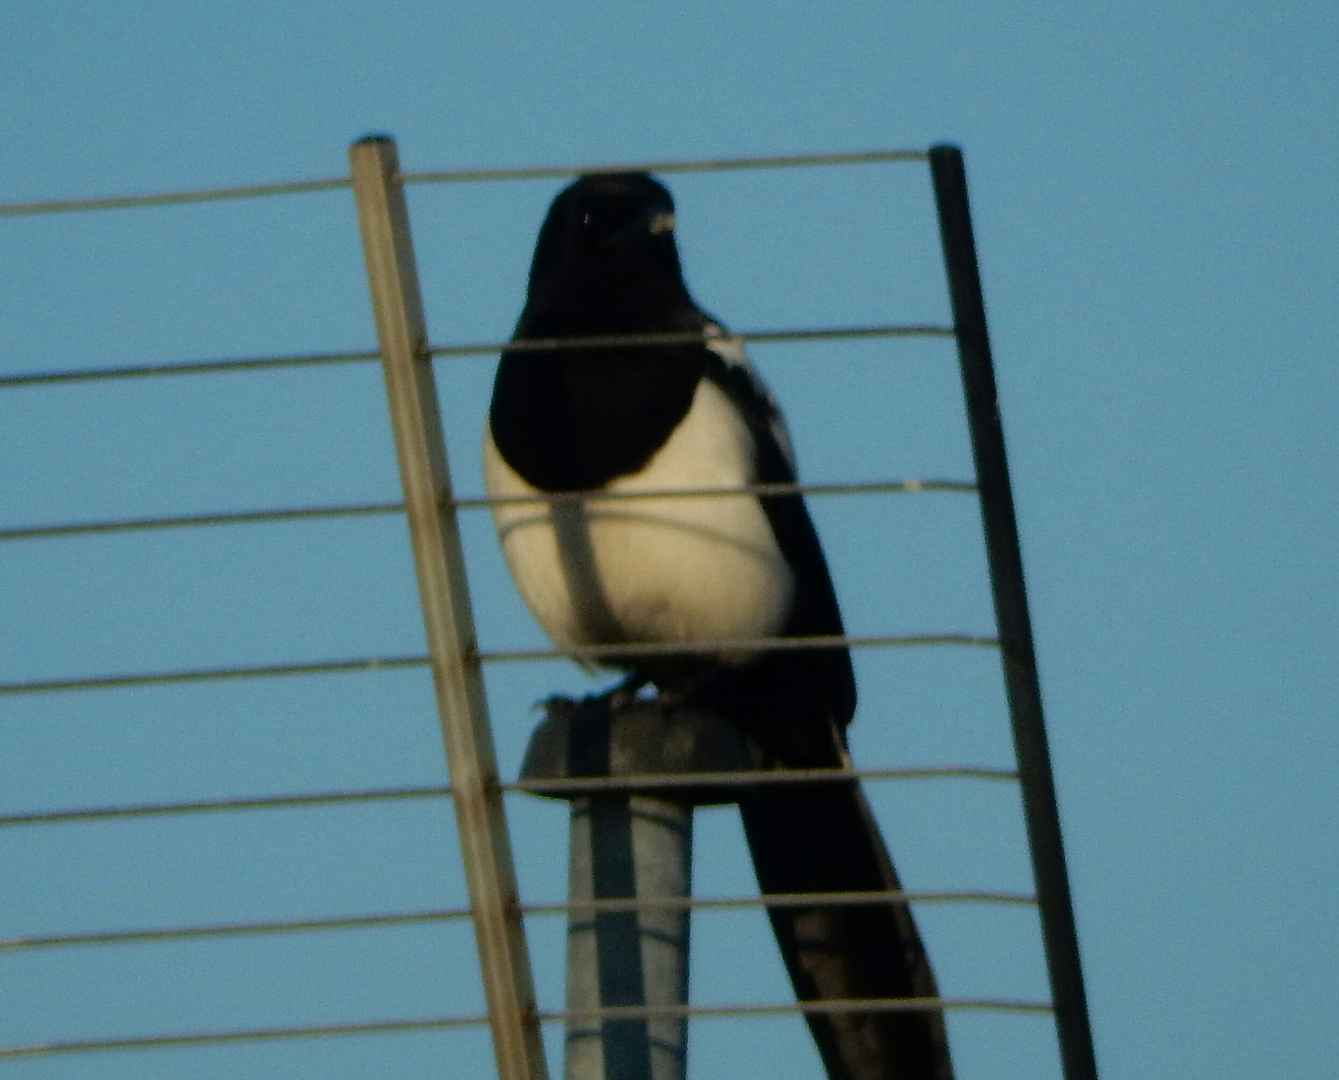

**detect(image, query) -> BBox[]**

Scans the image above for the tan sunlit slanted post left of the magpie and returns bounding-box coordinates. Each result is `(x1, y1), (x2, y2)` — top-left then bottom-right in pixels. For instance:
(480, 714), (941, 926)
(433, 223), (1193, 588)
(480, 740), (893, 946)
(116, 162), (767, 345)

(348, 137), (548, 1080)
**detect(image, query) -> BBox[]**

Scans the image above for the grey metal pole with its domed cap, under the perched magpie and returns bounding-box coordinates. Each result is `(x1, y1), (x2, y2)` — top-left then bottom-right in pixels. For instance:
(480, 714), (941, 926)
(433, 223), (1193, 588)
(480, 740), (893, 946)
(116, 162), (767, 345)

(532, 695), (696, 1080)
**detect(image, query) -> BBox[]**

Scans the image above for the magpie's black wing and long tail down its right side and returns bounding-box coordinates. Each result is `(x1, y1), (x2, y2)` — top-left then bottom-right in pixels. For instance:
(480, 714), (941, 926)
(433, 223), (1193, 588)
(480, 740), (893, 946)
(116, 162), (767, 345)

(690, 325), (953, 1080)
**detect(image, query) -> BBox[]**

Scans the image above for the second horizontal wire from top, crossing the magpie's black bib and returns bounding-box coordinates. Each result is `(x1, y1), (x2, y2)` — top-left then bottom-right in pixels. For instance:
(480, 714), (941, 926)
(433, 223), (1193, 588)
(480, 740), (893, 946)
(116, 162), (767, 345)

(0, 324), (953, 389)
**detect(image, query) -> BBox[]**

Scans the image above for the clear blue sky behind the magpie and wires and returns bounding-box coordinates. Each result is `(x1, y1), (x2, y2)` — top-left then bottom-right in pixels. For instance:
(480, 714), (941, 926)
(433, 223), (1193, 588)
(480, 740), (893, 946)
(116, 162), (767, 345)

(0, 0), (1339, 1080)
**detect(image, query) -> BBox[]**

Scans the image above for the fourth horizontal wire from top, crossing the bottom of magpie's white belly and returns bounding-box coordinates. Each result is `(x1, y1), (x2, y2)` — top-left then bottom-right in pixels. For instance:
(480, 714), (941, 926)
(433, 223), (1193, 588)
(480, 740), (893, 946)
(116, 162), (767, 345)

(0, 633), (999, 697)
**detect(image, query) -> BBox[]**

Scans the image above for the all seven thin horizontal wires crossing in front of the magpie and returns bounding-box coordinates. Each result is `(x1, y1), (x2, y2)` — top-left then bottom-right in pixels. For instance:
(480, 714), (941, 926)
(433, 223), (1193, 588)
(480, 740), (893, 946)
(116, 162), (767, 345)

(0, 150), (1071, 1075)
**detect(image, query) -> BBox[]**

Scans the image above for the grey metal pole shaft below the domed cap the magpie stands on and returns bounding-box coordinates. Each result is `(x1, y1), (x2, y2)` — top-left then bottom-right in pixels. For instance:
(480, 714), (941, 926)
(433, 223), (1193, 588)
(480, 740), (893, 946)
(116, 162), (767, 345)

(565, 794), (692, 1080)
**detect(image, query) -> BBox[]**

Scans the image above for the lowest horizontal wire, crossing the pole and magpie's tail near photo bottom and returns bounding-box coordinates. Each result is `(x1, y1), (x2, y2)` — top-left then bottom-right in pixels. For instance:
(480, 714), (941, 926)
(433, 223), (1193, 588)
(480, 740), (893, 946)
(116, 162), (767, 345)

(0, 997), (1052, 1059)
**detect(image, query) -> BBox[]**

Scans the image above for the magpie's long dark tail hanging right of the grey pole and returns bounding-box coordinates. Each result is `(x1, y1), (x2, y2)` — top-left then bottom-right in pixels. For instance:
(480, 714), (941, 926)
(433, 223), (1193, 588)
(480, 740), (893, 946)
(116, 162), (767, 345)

(739, 780), (953, 1080)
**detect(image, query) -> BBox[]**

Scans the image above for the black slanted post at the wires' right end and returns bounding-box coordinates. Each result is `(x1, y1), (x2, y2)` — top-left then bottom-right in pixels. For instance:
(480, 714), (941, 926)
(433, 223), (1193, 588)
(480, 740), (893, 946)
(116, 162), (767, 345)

(929, 146), (1097, 1080)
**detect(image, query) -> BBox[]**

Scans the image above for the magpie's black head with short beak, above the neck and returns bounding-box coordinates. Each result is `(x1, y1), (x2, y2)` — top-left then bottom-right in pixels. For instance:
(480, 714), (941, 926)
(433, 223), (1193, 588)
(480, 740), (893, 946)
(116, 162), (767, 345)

(530, 173), (687, 325)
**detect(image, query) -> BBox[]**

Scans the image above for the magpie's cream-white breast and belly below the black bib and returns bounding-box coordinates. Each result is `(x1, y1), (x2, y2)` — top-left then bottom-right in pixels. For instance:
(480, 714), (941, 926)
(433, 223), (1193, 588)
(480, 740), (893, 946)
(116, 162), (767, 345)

(483, 379), (794, 661)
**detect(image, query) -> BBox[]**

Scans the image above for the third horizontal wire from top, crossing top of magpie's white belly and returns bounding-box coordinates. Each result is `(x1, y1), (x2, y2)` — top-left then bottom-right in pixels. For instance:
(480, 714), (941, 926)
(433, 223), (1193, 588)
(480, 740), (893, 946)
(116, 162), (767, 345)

(0, 479), (976, 542)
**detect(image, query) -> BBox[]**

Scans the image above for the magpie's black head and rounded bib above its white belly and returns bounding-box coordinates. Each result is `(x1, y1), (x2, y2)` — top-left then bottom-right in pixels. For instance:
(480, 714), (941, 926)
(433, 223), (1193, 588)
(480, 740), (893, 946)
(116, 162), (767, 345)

(489, 174), (707, 491)
